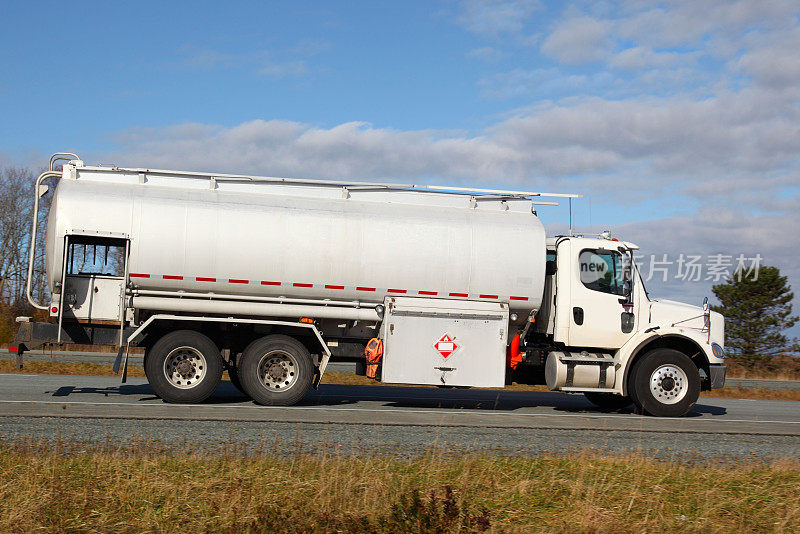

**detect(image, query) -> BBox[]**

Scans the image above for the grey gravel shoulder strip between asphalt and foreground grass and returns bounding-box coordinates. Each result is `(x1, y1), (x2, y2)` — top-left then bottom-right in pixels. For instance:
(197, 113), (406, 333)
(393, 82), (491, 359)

(0, 417), (800, 462)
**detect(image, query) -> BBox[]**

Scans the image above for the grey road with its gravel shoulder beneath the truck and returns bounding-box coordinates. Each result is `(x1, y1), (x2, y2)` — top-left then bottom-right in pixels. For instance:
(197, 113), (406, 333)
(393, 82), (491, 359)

(0, 375), (800, 459)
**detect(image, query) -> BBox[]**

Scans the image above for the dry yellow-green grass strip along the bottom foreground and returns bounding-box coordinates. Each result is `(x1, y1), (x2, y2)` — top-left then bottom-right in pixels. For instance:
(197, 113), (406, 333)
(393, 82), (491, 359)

(0, 442), (800, 533)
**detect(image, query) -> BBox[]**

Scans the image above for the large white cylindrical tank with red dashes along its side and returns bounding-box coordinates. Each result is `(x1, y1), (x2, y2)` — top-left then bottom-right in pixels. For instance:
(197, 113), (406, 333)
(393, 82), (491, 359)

(47, 162), (545, 313)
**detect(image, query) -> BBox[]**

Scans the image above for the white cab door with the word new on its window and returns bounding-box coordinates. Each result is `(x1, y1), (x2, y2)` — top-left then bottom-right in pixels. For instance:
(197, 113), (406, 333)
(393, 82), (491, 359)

(568, 244), (636, 349)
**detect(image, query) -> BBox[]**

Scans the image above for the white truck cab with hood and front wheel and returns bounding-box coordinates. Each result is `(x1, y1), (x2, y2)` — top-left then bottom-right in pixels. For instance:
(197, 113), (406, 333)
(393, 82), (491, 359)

(523, 238), (726, 416)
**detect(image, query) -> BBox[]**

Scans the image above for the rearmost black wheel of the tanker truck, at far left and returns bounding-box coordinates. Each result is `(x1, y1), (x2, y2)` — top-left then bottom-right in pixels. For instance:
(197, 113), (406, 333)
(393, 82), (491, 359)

(145, 330), (222, 404)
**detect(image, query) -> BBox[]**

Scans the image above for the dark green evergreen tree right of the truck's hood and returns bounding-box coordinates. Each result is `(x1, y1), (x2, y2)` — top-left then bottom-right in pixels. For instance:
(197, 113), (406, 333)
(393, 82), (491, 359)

(712, 266), (798, 369)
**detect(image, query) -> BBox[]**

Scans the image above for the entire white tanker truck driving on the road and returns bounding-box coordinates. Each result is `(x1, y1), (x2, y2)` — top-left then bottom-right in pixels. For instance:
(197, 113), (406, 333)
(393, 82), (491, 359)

(9, 153), (726, 416)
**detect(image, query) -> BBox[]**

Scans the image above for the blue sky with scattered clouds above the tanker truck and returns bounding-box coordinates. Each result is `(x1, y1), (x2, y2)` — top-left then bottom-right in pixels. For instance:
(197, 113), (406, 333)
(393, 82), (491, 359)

(0, 0), (800, 330)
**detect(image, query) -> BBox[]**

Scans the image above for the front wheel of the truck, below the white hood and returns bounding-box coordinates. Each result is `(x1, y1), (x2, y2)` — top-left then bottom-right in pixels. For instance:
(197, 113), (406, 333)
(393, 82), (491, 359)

(631, 349), (700, 417)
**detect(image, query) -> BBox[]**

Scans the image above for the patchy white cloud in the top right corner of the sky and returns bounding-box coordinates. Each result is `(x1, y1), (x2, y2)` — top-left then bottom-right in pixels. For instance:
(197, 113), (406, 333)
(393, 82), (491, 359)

(539, 0), (800, 94)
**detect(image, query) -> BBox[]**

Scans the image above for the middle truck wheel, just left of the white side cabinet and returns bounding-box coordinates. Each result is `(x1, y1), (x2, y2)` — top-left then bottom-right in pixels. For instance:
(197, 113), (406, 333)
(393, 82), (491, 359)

(238, 335), (314, 406)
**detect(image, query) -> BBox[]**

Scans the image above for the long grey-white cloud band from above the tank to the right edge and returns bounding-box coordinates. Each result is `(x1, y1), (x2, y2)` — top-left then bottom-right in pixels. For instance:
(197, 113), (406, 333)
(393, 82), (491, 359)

(106, 81), (800, 198)
